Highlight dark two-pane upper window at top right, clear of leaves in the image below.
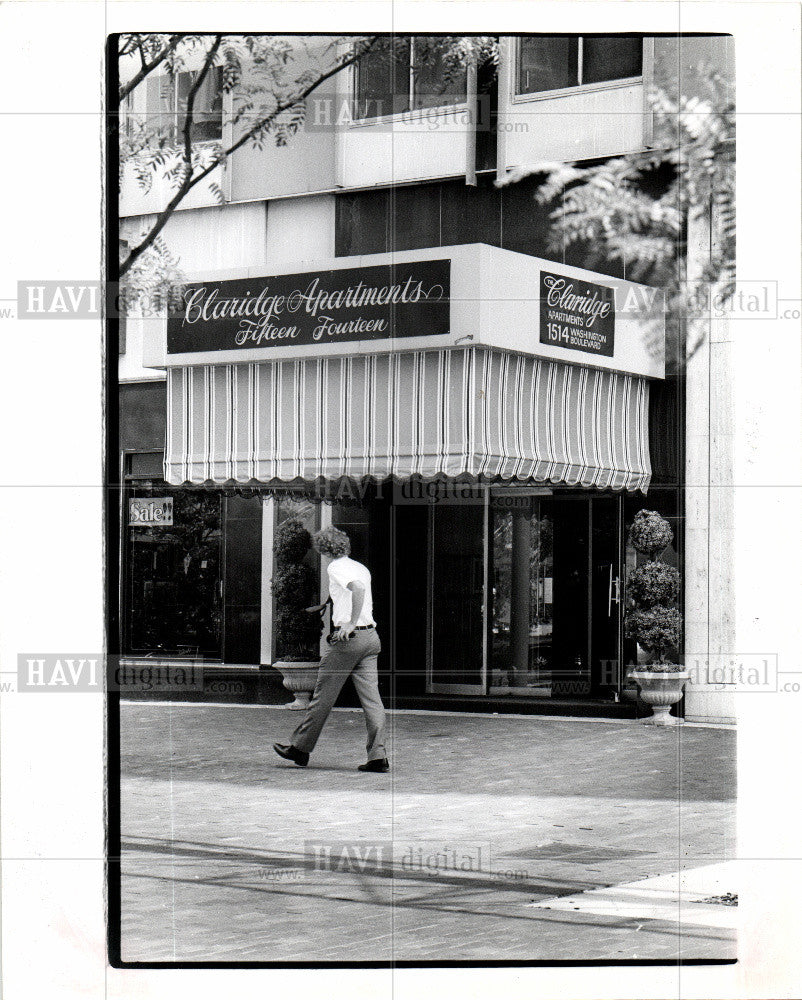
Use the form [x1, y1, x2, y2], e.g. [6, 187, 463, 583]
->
[517, 35, 643, 94]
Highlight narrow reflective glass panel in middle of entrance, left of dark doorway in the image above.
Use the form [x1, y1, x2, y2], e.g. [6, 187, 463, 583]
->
[490, 492, 554, 697]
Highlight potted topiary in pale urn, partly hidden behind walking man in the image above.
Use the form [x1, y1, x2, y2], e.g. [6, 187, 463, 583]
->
[273, 518, 323, 710]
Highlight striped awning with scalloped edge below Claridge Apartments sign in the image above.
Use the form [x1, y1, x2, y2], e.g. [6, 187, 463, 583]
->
[165, 347, 651, 492]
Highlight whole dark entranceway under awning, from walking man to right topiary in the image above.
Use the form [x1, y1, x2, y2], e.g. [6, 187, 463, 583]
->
[302, 486, 624, 701]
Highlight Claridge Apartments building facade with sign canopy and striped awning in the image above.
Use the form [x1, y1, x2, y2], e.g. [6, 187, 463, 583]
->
[119, 35, 734, 721]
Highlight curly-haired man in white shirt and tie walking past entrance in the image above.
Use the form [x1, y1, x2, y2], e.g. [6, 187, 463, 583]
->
[273, 527, 390, 773]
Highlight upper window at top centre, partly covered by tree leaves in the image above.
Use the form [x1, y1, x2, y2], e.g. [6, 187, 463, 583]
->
[354, 35, 465, 119]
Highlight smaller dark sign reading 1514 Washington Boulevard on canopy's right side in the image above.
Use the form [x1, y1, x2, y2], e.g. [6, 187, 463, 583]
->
[540, 271, 615, 358]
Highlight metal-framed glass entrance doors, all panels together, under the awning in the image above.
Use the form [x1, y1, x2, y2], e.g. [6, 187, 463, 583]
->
[418, 487, 623, 701]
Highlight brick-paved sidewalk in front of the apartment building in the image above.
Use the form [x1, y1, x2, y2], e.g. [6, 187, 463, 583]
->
[115, 703, 735, 962]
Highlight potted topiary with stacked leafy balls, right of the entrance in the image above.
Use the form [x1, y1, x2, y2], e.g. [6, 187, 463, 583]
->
[624, 510, 689, 726]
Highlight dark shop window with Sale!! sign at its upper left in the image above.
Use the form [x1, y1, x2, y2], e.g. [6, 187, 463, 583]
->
[125, 482, 222, 659]
